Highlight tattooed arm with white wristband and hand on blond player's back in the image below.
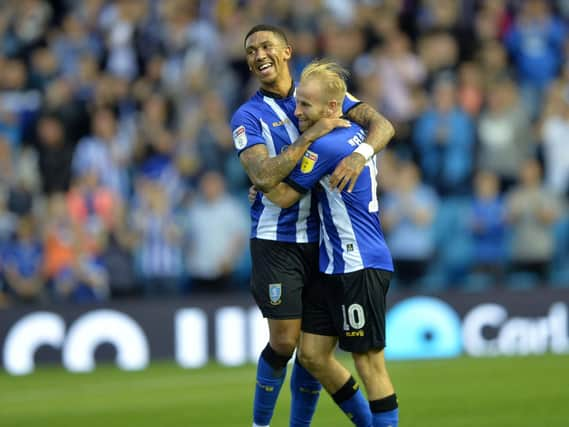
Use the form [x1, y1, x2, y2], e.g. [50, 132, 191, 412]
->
[330, 102, 395, 192]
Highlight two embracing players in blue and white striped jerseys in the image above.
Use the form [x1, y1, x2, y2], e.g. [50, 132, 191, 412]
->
[231, 25, 398, 427]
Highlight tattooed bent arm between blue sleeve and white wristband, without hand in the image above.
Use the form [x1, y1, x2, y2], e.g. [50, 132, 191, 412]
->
[347, 103, 395, 153]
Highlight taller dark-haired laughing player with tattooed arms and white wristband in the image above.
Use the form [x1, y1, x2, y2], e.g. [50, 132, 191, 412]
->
[231, 25, 394, 427]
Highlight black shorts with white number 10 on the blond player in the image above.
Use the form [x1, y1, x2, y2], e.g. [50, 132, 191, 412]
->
[302, 269, 392, 353]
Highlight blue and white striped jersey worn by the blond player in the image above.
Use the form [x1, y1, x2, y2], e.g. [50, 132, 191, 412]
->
[286, 123, 393, 274]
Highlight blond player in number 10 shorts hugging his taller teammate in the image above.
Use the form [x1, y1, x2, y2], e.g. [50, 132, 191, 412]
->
[265, 61, 398, 427]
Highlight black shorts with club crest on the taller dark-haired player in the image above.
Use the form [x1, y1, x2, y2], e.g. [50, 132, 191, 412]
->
[250, 239, 319, 319]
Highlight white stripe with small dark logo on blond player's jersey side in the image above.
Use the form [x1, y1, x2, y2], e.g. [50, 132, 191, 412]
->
[320, 175, 364, 273]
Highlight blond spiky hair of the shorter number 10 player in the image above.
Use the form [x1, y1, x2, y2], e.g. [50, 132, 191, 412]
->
[300, 59, 350, 103]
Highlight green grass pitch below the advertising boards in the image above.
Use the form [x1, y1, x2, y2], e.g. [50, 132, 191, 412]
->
[0, 355, 569, 427]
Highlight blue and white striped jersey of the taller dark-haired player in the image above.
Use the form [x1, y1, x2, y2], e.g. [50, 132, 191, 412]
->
[231, 85, 360, 243]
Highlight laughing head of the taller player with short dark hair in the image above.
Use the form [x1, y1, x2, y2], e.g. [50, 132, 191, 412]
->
[245, 31, 292, 91]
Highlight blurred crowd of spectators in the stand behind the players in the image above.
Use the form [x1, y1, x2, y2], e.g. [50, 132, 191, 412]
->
[0, 0, 569, 306]
